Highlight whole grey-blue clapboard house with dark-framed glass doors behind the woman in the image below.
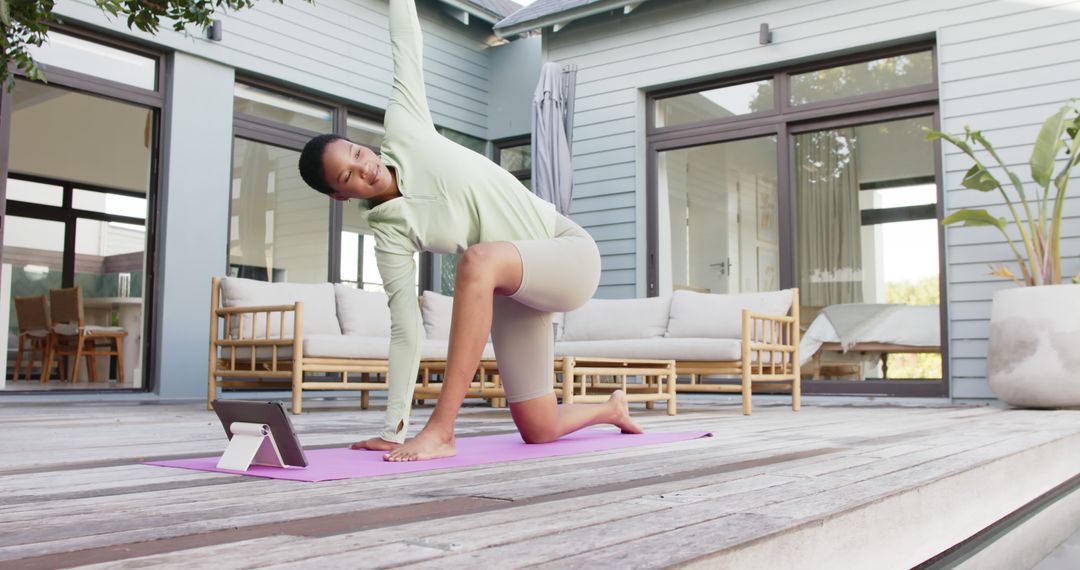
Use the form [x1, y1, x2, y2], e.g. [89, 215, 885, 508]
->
[0, 0, 1080, 398]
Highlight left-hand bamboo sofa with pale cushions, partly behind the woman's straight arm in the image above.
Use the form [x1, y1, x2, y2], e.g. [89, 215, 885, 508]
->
[206, 277, 495, 413]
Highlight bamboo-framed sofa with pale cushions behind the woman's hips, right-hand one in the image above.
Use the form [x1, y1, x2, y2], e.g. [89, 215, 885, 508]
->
[555, 288, 801, 415]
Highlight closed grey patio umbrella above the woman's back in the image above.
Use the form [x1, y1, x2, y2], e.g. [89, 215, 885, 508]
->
[532, 62, 577, 215]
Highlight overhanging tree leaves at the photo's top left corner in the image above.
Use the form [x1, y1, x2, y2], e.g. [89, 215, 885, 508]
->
[0, 0, 300, 90]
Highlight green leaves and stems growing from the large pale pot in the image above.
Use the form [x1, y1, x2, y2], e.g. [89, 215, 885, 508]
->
[927, 99, 1080, 285]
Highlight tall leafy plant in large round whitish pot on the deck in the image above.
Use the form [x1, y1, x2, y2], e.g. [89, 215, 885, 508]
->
[927, 99, 1080, 408]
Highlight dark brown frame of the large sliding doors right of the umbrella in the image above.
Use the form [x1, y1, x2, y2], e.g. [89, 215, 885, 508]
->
[645, 40, 950, 397]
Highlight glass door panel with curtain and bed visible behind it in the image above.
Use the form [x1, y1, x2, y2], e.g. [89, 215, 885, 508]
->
[794, 117, 942, 381]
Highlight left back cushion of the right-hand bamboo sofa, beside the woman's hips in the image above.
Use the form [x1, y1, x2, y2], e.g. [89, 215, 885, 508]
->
[559, 297, 671, 340]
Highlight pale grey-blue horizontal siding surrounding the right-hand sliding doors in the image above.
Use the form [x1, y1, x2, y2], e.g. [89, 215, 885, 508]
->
[544, 0, 1080, 398]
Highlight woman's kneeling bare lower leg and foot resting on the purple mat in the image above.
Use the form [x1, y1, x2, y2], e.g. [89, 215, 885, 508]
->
[510, 390, 643, 444]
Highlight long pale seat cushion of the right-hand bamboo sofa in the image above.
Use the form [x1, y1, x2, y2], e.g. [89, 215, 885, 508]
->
[555, 338, 742, 362]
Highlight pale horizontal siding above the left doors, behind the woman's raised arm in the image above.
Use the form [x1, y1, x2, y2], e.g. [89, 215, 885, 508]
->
[56, 0, 490, 139]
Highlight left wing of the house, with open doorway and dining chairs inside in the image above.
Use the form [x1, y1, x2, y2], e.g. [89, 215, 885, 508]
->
[0, 0, 540, 397]
